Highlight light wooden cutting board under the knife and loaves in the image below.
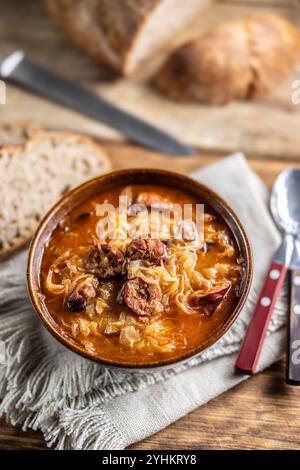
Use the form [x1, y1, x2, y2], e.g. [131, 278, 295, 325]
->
[0, 0, 300, 159]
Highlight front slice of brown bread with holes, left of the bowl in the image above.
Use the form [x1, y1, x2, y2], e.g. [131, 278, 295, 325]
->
[0, 128, 111, 258]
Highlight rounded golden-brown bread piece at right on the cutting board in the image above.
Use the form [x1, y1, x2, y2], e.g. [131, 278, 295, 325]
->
[154, 13, 300, 104]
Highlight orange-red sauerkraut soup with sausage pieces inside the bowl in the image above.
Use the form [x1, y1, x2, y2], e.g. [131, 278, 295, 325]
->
[41, 185, 243, 365]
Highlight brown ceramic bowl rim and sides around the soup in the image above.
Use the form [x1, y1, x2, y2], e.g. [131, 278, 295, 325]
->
[27, 169, 252, 371]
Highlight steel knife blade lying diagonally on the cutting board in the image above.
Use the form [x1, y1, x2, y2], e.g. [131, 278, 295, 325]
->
[0, 51, 195, 155]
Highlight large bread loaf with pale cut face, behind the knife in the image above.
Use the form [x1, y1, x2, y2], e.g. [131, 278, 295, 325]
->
[44, 0, 212, 76]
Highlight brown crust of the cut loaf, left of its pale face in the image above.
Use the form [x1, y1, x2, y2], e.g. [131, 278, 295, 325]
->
[44, 0, 161, 74]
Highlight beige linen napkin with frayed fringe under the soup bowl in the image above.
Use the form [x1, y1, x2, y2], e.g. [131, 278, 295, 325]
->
[0, 154, 286, 450]
